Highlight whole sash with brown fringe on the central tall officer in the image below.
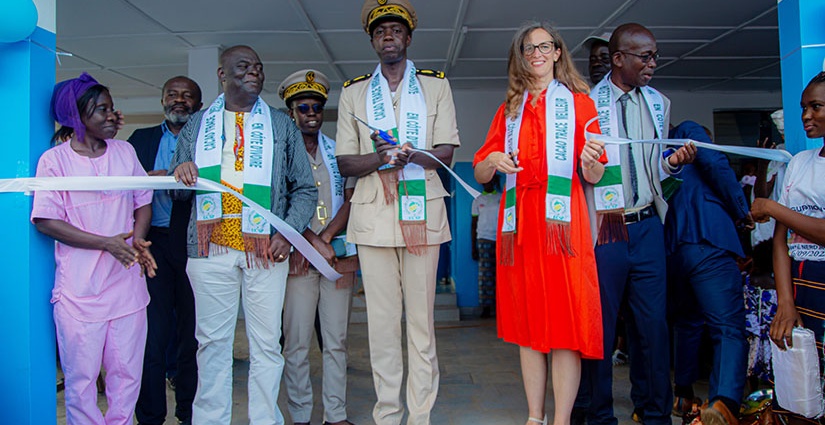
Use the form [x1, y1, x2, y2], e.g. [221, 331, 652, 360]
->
[366, 60, 427, 255]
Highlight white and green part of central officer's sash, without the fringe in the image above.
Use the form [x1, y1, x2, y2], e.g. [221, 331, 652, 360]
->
[366, 60, 427, 221]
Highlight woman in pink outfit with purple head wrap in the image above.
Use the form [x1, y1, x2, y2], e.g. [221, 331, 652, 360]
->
[31, 73, 157, 425]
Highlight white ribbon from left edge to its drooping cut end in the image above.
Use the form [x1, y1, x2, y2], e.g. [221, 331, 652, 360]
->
[0, 176, 342, 282]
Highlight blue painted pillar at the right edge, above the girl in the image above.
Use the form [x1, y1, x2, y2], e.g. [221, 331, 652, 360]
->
[778, 0, 825, 154]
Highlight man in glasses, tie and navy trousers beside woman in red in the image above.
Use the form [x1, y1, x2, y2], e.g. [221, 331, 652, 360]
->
[581, 23, 696, 425]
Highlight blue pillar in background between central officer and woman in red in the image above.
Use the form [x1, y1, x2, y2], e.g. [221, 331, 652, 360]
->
[450, 162, 482, 313]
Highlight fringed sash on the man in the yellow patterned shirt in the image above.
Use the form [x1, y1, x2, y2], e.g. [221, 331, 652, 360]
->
[195, 94, 275, 267]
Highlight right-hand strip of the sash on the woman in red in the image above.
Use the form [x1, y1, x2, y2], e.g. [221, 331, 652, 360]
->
[548, 80, 576, 223]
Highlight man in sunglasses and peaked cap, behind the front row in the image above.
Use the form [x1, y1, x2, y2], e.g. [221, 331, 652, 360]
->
[278, 69, 358, 425]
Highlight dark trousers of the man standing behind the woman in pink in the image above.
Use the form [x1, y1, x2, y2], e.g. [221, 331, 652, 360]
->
[135, 227, 198, 425]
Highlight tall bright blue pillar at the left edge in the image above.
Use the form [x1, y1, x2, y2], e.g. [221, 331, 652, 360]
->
[0, 0, 57, 424]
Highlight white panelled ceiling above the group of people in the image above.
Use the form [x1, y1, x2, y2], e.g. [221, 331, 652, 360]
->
[57, 0, 780, 101]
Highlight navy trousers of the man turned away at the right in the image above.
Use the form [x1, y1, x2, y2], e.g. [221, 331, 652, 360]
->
[667, 244, 748, 402]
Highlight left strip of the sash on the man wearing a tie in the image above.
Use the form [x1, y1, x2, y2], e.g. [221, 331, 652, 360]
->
[585, 74, 625, 212]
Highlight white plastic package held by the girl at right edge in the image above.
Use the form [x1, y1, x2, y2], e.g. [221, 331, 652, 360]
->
[771, 328, 825, 418]
